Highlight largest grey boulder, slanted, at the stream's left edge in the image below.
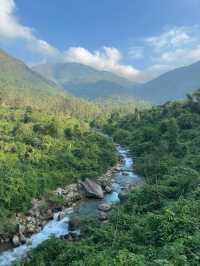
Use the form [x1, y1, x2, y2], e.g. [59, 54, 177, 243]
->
[81, 178, 104, 199]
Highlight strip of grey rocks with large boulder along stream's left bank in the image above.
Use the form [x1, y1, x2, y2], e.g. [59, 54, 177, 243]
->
[5, 158, 122, 246]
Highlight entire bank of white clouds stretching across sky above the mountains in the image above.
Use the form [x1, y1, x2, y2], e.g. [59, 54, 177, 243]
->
[0, 0, 200, 82]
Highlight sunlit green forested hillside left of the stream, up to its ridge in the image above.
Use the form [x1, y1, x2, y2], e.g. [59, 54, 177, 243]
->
[0, 48, 150, 250]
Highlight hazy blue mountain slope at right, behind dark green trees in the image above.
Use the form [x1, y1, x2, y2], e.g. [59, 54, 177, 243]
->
[134, 62, 200, 104]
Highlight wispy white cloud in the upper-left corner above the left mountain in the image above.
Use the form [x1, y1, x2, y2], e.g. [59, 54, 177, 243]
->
[0, 0, 60, 60]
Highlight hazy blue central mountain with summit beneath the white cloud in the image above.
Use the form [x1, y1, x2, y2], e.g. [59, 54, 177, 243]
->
[32, 63, 134, 100]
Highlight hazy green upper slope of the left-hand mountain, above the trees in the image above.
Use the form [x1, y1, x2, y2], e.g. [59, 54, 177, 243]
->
[0, 49, 61, 95]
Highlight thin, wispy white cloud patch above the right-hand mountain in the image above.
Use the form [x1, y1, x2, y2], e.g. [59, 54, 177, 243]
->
[139, 25, 200, 80]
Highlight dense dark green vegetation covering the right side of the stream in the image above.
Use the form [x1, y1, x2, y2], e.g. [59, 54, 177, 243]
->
[25, 91, 200, 266]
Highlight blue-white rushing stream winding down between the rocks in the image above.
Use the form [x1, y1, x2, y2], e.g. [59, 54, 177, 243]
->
[0, 146, 140, 266]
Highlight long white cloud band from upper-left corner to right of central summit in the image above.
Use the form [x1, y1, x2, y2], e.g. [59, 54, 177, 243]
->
[0, 0, 140, 80]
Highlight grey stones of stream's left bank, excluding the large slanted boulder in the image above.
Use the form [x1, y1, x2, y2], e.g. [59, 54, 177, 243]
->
[0, 152, 123, 251]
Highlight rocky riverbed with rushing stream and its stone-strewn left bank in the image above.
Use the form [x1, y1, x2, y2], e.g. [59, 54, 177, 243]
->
[0, 147, 141, 266]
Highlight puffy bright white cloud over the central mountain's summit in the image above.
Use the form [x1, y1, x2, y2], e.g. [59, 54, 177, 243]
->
[64, 47, 141, 81]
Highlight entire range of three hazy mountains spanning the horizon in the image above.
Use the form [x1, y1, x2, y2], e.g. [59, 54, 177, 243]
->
[0, 49, 200, 104]
